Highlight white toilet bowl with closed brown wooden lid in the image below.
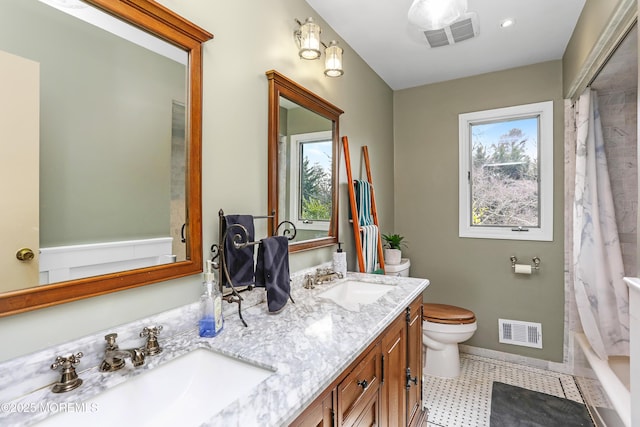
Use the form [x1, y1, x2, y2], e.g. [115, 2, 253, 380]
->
[422, 303, 478, 378]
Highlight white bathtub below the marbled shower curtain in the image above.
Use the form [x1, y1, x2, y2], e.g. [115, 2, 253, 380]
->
[575, 333, 631, 427]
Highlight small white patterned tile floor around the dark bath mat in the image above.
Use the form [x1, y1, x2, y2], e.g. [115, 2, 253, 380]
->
[423, 354, 583, 427]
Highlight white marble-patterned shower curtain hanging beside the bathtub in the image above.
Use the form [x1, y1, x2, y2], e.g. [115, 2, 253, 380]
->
[573, 89, 629, 360]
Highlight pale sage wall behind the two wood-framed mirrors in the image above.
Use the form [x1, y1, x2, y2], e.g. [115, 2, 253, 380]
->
[0, 0, 394, 361]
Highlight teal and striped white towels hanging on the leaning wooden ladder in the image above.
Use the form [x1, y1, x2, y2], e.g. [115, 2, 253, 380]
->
[353, 180, 378, 273]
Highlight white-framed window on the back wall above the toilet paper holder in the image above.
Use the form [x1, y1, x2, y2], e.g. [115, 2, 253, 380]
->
[459, 101, 553, 241]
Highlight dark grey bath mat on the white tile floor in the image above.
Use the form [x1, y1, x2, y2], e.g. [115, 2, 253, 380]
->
[490, 382, 593, 427]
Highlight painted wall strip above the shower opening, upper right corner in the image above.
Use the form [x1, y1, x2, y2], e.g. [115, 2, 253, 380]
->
[562, 0, 622, 96]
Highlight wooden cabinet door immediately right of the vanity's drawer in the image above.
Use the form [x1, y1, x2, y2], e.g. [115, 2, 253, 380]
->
[380, 315, 407, 427]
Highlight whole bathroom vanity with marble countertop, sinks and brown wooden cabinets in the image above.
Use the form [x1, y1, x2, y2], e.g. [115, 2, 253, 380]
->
[0, 270, 429, 426]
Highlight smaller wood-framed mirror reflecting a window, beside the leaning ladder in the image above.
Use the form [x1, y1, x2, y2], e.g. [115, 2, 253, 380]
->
[266, 70, 343, 252]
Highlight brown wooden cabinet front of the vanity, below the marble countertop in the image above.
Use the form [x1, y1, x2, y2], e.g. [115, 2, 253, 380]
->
[291, 296, 426, 427]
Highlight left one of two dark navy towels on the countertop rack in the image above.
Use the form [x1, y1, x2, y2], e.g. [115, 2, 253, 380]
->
[221, 215, 255, 286]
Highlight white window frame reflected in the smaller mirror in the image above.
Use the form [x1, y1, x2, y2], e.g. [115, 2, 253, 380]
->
[289, 130, 335, 232]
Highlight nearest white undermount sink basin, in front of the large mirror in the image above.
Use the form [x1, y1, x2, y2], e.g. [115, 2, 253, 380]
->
[38, 348, 273, 427]
